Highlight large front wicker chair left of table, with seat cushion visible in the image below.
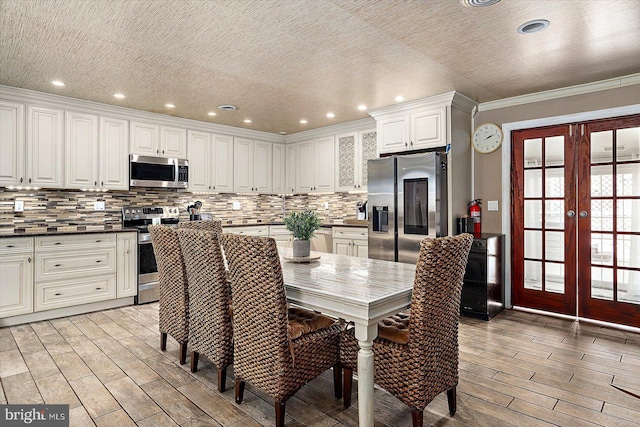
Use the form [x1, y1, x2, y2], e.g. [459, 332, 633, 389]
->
[221, 234, 342, 426]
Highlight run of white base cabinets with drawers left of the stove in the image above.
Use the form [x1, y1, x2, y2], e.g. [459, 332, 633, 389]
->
[0, 232, 137, 326]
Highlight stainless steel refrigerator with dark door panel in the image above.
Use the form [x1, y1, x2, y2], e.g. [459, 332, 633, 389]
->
[367, 152, 448, 263]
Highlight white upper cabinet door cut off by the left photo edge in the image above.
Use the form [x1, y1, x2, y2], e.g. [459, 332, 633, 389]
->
[0, 99, 26, 187]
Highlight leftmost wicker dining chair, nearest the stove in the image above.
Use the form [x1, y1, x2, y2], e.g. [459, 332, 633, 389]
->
[149, 225, 189, 365]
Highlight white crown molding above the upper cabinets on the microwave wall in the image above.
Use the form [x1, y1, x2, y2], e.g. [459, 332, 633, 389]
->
[0, 85, 284, 143]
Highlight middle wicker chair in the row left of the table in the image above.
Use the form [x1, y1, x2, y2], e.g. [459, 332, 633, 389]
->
[177, 229, 233, 392]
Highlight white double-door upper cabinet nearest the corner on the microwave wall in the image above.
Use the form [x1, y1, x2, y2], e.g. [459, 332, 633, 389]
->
[233, 137, 273, 194]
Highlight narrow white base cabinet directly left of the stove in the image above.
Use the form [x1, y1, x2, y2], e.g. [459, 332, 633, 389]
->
[116, 233, 138, 298]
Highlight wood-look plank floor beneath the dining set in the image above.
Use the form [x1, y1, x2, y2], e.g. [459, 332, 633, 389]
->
[0, 303, 640, 427]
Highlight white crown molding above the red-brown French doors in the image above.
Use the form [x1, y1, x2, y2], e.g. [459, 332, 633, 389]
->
[478, 73, 640, 111]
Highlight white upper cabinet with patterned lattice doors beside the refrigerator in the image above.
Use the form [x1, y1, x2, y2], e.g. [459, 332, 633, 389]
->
[335, 129, 378, 191]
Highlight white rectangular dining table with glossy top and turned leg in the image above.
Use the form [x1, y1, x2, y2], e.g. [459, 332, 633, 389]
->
[278, 246, 416, 427]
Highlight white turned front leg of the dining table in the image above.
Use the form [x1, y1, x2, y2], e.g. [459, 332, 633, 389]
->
[355, 323, 378, 427]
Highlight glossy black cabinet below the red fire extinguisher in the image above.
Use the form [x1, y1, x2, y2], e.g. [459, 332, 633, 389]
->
[460, 234, 504, 320]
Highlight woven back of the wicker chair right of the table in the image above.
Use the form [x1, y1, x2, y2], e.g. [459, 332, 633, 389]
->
[409, 233, 473, 383]
